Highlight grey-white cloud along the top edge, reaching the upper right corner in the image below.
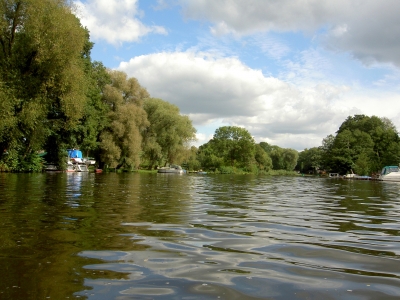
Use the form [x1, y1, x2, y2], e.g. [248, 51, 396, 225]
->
[180, 0, 400, 67]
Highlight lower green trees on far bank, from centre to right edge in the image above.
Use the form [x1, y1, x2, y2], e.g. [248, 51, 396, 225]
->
[188, 115, 400, 175]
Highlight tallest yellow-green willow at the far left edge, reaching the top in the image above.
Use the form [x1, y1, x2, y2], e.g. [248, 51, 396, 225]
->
[0, 0, 88, 169]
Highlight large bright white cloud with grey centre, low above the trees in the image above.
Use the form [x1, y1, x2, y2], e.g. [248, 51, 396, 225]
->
[118, 52, 368, 149]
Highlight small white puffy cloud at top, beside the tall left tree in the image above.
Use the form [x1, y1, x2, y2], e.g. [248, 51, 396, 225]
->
[75, 0, 167, 45]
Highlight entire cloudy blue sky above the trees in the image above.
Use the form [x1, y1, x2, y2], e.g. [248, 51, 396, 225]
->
[75, 0, 400, 150]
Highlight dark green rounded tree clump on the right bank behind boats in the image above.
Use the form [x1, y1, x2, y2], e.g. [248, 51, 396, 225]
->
[297, 115, 400, 175]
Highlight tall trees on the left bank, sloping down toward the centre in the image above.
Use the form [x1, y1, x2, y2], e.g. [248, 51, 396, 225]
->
[0, 0, 196, 172]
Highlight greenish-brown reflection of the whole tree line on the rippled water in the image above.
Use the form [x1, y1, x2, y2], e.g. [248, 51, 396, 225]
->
[0, 173, 400, 299]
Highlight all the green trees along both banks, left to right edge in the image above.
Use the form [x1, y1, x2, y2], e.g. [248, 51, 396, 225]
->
[0, 0, 400, 175]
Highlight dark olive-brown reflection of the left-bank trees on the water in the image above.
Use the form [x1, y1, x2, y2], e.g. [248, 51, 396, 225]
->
[0, 173, 173, 299]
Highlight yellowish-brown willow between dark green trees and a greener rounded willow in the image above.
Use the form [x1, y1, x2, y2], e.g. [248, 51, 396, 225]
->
[100, 70, 149, 168]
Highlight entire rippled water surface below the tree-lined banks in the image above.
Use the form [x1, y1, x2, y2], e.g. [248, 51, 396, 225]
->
[0, 173, 400, 300]
